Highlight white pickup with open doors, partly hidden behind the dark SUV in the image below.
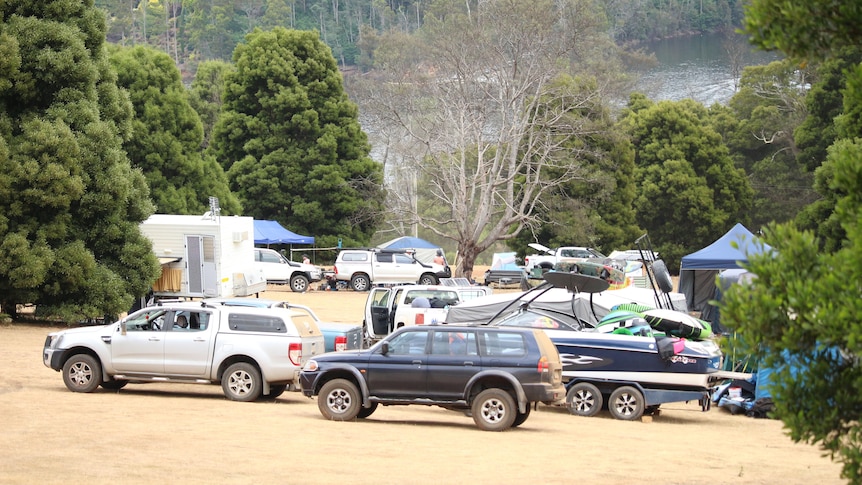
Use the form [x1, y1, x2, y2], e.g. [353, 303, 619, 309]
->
[362, 285, 493, 345]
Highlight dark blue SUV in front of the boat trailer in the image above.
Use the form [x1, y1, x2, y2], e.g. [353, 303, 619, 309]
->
[300, 325, 565, 431]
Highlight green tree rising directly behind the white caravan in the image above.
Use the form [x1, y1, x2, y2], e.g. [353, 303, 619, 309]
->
[110, 46, 240, 214]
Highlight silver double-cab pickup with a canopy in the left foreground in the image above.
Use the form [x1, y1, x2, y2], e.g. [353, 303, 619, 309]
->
[42, 302, 324, 401]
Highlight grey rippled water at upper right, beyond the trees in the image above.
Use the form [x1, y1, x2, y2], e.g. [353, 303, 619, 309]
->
[636, 34, 780, 106]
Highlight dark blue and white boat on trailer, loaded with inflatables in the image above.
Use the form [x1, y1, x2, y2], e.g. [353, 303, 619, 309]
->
[482, 271, 740, 420]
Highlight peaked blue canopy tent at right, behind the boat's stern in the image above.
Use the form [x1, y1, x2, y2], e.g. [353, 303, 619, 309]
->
[679, 223, 772, 328]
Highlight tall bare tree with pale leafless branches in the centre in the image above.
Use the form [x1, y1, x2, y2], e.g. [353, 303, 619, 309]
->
[363, 0, 624, 276]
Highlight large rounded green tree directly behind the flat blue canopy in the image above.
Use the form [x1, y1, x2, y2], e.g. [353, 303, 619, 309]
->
[211, 28, 383, 244]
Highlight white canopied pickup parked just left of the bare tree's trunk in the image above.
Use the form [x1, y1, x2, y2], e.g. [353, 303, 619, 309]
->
[334, 249, 452, 291]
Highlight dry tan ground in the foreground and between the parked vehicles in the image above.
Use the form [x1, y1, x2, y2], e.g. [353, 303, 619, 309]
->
[0, 287, 843, 485]
